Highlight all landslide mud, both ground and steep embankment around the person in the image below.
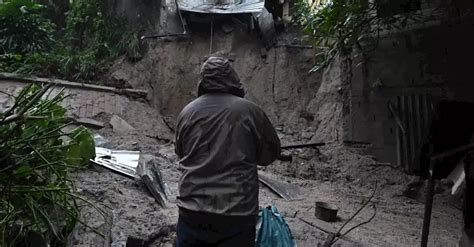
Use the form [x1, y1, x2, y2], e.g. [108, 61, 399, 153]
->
[70, 23, 462, 246]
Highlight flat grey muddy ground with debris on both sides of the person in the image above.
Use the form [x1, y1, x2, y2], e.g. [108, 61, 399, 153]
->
[71, 106, 461, 246]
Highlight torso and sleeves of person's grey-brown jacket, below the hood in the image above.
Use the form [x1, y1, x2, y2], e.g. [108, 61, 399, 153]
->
[176, 93, 280, 216]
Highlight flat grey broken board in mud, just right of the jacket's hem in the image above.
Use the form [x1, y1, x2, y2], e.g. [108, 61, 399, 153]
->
[258, 171, 303, 201]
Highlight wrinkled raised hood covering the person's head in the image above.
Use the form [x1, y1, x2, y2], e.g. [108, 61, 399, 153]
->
[198, 57, 245, 97]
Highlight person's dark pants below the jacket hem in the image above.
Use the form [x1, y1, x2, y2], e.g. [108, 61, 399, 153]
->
[176, 208, 257, 247]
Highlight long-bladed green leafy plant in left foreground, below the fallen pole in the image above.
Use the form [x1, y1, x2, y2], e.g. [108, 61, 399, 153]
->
[0, 84, 95, 246]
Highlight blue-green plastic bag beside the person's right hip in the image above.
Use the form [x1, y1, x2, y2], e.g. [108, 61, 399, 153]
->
[255, 206, 296, 247]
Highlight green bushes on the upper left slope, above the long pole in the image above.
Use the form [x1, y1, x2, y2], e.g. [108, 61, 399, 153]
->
[0, 0, 143, 81]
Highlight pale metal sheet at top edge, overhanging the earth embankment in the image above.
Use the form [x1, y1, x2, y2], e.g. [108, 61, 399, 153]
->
[178, 0, 265, 14]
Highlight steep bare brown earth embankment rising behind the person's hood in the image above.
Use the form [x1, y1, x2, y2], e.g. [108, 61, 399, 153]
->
[106, 28, 321, 131]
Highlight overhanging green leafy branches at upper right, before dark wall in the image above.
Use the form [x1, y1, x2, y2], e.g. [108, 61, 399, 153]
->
[293, 0, 419, 71]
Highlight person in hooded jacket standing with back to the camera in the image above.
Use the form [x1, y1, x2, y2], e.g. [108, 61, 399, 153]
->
[175, 57, 280, 247]
